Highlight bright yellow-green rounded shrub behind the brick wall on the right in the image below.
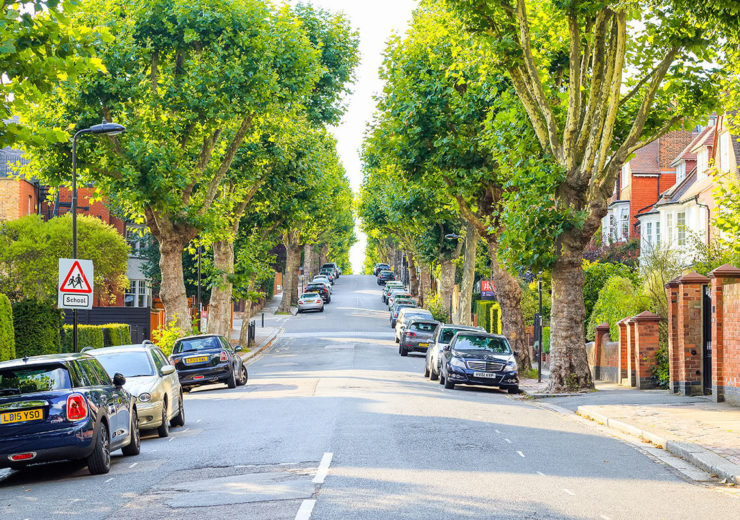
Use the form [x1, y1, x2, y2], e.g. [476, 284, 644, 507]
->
[587, 276, 650, 340]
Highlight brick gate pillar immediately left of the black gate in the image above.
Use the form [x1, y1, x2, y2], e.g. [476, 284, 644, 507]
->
[677, 271, 709, 395]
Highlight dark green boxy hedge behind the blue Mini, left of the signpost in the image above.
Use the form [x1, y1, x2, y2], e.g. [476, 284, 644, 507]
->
[13, 300, 63, 358]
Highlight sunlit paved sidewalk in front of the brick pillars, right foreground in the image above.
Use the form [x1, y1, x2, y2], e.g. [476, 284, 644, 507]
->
[520, 380, 740, 484]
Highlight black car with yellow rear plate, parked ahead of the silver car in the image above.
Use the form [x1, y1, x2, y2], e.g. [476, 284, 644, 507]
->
[170, 334, 248, 392]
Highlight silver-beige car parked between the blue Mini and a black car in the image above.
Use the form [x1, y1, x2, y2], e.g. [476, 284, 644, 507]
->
[88, 343, 185, 437]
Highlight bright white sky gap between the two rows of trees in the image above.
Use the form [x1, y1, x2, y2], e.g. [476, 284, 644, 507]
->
[292, 0, 418, 273]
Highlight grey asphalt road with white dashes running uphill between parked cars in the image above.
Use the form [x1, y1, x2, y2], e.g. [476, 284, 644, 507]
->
[0, 276, 740, 520]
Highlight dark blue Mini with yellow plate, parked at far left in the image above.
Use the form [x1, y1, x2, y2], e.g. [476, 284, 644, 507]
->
[0, 354, 140, 475]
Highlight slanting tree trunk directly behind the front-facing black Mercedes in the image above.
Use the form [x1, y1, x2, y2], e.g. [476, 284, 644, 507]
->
[488, 238, 532, 370]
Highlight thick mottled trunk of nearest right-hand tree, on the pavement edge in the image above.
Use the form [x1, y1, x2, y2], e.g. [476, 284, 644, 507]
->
[549, 247, 594, 392]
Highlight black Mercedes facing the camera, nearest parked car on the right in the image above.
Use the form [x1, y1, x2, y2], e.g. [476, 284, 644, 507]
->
[439, 332, 519, 394]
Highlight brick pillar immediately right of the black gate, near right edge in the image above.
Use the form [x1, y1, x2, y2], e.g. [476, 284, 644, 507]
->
[709, 264, 740, 402]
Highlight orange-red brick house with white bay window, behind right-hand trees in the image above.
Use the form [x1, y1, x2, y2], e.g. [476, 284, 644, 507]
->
[602, 130, 698, 243]
